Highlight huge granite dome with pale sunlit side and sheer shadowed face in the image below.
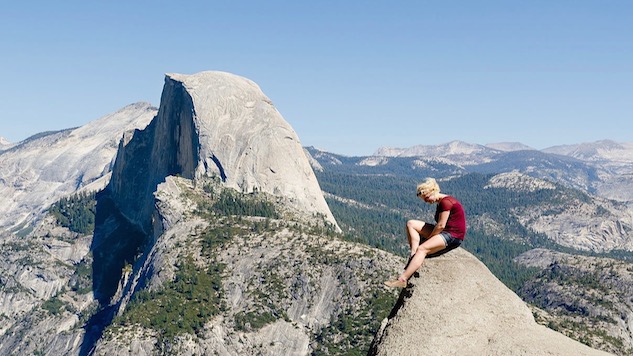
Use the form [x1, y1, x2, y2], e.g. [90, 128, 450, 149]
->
[110, 72, 336, 232]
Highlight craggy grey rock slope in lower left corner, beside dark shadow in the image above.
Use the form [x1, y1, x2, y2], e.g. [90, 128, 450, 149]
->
[0, 217, 95, 355]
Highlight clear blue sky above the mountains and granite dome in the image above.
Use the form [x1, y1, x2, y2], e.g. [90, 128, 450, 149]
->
[0, 0, 633, 155]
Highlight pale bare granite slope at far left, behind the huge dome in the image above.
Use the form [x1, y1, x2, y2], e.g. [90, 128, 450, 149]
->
[0, 103, 156, 230]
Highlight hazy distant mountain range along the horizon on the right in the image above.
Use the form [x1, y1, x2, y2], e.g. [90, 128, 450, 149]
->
[366, 140, 633, 202]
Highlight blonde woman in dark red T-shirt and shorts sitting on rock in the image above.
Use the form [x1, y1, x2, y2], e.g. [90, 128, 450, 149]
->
[385, 178, 466, 288]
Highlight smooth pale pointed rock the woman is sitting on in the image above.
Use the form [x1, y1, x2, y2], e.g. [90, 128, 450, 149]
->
[369, 249, 606, 356]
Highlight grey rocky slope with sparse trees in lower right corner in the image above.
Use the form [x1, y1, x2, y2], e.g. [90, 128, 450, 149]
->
[515, 248, 633, 355]
